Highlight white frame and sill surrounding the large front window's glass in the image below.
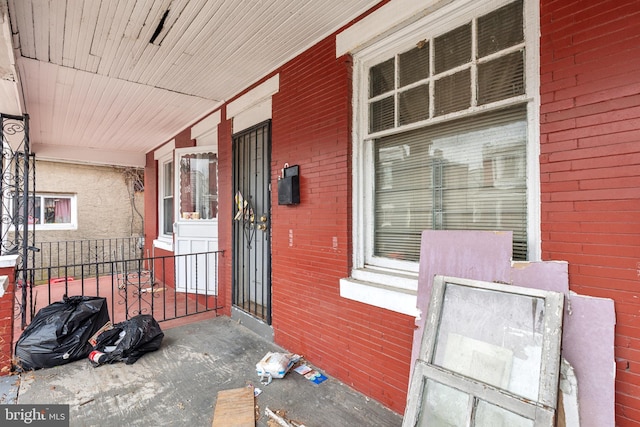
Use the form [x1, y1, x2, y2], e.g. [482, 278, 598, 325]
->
[340, 0, 541, 315]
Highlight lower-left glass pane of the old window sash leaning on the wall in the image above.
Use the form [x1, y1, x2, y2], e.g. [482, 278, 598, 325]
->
[417, 380, 472, 427]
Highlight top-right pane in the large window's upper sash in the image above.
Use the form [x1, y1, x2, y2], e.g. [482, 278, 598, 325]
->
[478, 1, 524, 58]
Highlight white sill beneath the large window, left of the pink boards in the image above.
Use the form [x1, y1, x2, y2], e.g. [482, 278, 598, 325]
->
[340, 268, 419, 317]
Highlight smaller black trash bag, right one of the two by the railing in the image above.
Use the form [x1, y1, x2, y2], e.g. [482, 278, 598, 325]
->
[89, 314, 164, 367]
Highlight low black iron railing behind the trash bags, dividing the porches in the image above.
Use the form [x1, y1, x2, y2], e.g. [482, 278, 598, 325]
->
[18, 249, 223, 323]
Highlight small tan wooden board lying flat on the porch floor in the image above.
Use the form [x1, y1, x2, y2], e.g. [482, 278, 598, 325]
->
[211, 387, 256, 427]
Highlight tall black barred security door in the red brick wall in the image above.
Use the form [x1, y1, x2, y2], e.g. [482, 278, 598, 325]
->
[233, 121, 271, 324]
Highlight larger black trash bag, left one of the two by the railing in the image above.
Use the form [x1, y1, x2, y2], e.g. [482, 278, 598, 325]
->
[15, 295, 110, 371]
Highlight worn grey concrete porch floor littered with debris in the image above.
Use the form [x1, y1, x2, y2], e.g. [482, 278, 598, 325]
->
[0, 317, 402, 427]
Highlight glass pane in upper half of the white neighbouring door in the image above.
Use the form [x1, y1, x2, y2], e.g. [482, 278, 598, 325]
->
[180, 153, 218, 219]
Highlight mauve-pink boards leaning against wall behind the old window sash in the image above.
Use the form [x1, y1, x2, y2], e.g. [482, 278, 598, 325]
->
[411, 230, 615, 427]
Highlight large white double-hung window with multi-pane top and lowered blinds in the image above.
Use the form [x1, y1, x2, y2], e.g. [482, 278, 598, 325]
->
[344, 0, 538, 314]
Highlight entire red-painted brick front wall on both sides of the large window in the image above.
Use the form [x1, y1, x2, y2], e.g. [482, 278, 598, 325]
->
[141, 0, 640, 427]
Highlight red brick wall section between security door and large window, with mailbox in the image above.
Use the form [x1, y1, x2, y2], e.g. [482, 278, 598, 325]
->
[272, 38, 414, 413]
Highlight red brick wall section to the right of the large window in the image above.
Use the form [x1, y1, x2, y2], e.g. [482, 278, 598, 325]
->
[540, 0, 640, 427]
